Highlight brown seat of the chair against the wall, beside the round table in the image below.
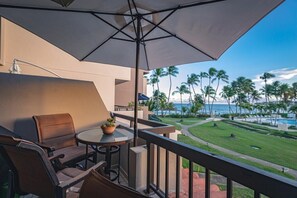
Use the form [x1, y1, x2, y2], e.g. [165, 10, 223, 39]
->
[54, 145, 95, 164]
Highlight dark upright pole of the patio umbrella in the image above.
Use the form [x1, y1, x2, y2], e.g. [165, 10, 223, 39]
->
[133, 15, 141, 146]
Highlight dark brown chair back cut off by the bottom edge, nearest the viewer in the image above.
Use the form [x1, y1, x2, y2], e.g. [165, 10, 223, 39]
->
[79, 170, 147, 198]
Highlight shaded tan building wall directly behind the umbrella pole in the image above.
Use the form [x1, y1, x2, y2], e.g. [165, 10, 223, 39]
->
[115, 69, 147, 106]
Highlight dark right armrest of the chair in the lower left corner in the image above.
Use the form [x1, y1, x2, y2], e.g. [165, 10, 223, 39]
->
[58, 161, 106, 190]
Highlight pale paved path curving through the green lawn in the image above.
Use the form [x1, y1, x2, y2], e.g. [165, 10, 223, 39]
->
[181, 119, 297, 178]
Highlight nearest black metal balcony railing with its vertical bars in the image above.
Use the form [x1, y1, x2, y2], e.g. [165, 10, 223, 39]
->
[139, 130, 297, 198]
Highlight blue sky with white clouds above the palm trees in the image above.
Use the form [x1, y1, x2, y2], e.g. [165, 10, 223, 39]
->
[147, 0, 297, 101]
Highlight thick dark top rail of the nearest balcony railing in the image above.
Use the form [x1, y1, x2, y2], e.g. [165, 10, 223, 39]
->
[139, 129, 297, 198]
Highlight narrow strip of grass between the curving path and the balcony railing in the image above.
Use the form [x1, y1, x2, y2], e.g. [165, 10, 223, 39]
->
[178, 135, 295, 179]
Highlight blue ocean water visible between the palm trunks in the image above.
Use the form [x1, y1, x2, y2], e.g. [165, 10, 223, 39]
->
[155, 103, 236, 115]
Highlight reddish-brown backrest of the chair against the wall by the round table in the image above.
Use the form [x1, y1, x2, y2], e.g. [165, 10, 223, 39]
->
[33, 113, 76, 149]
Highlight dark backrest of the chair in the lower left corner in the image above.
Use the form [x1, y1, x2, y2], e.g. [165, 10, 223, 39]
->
[0, 135, 59, 197]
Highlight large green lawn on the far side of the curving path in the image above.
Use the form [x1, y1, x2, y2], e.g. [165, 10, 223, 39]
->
[189, 122, 297, 170]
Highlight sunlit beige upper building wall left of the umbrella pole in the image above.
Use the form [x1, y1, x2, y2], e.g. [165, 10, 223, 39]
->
[0, 19, 131, 110]
